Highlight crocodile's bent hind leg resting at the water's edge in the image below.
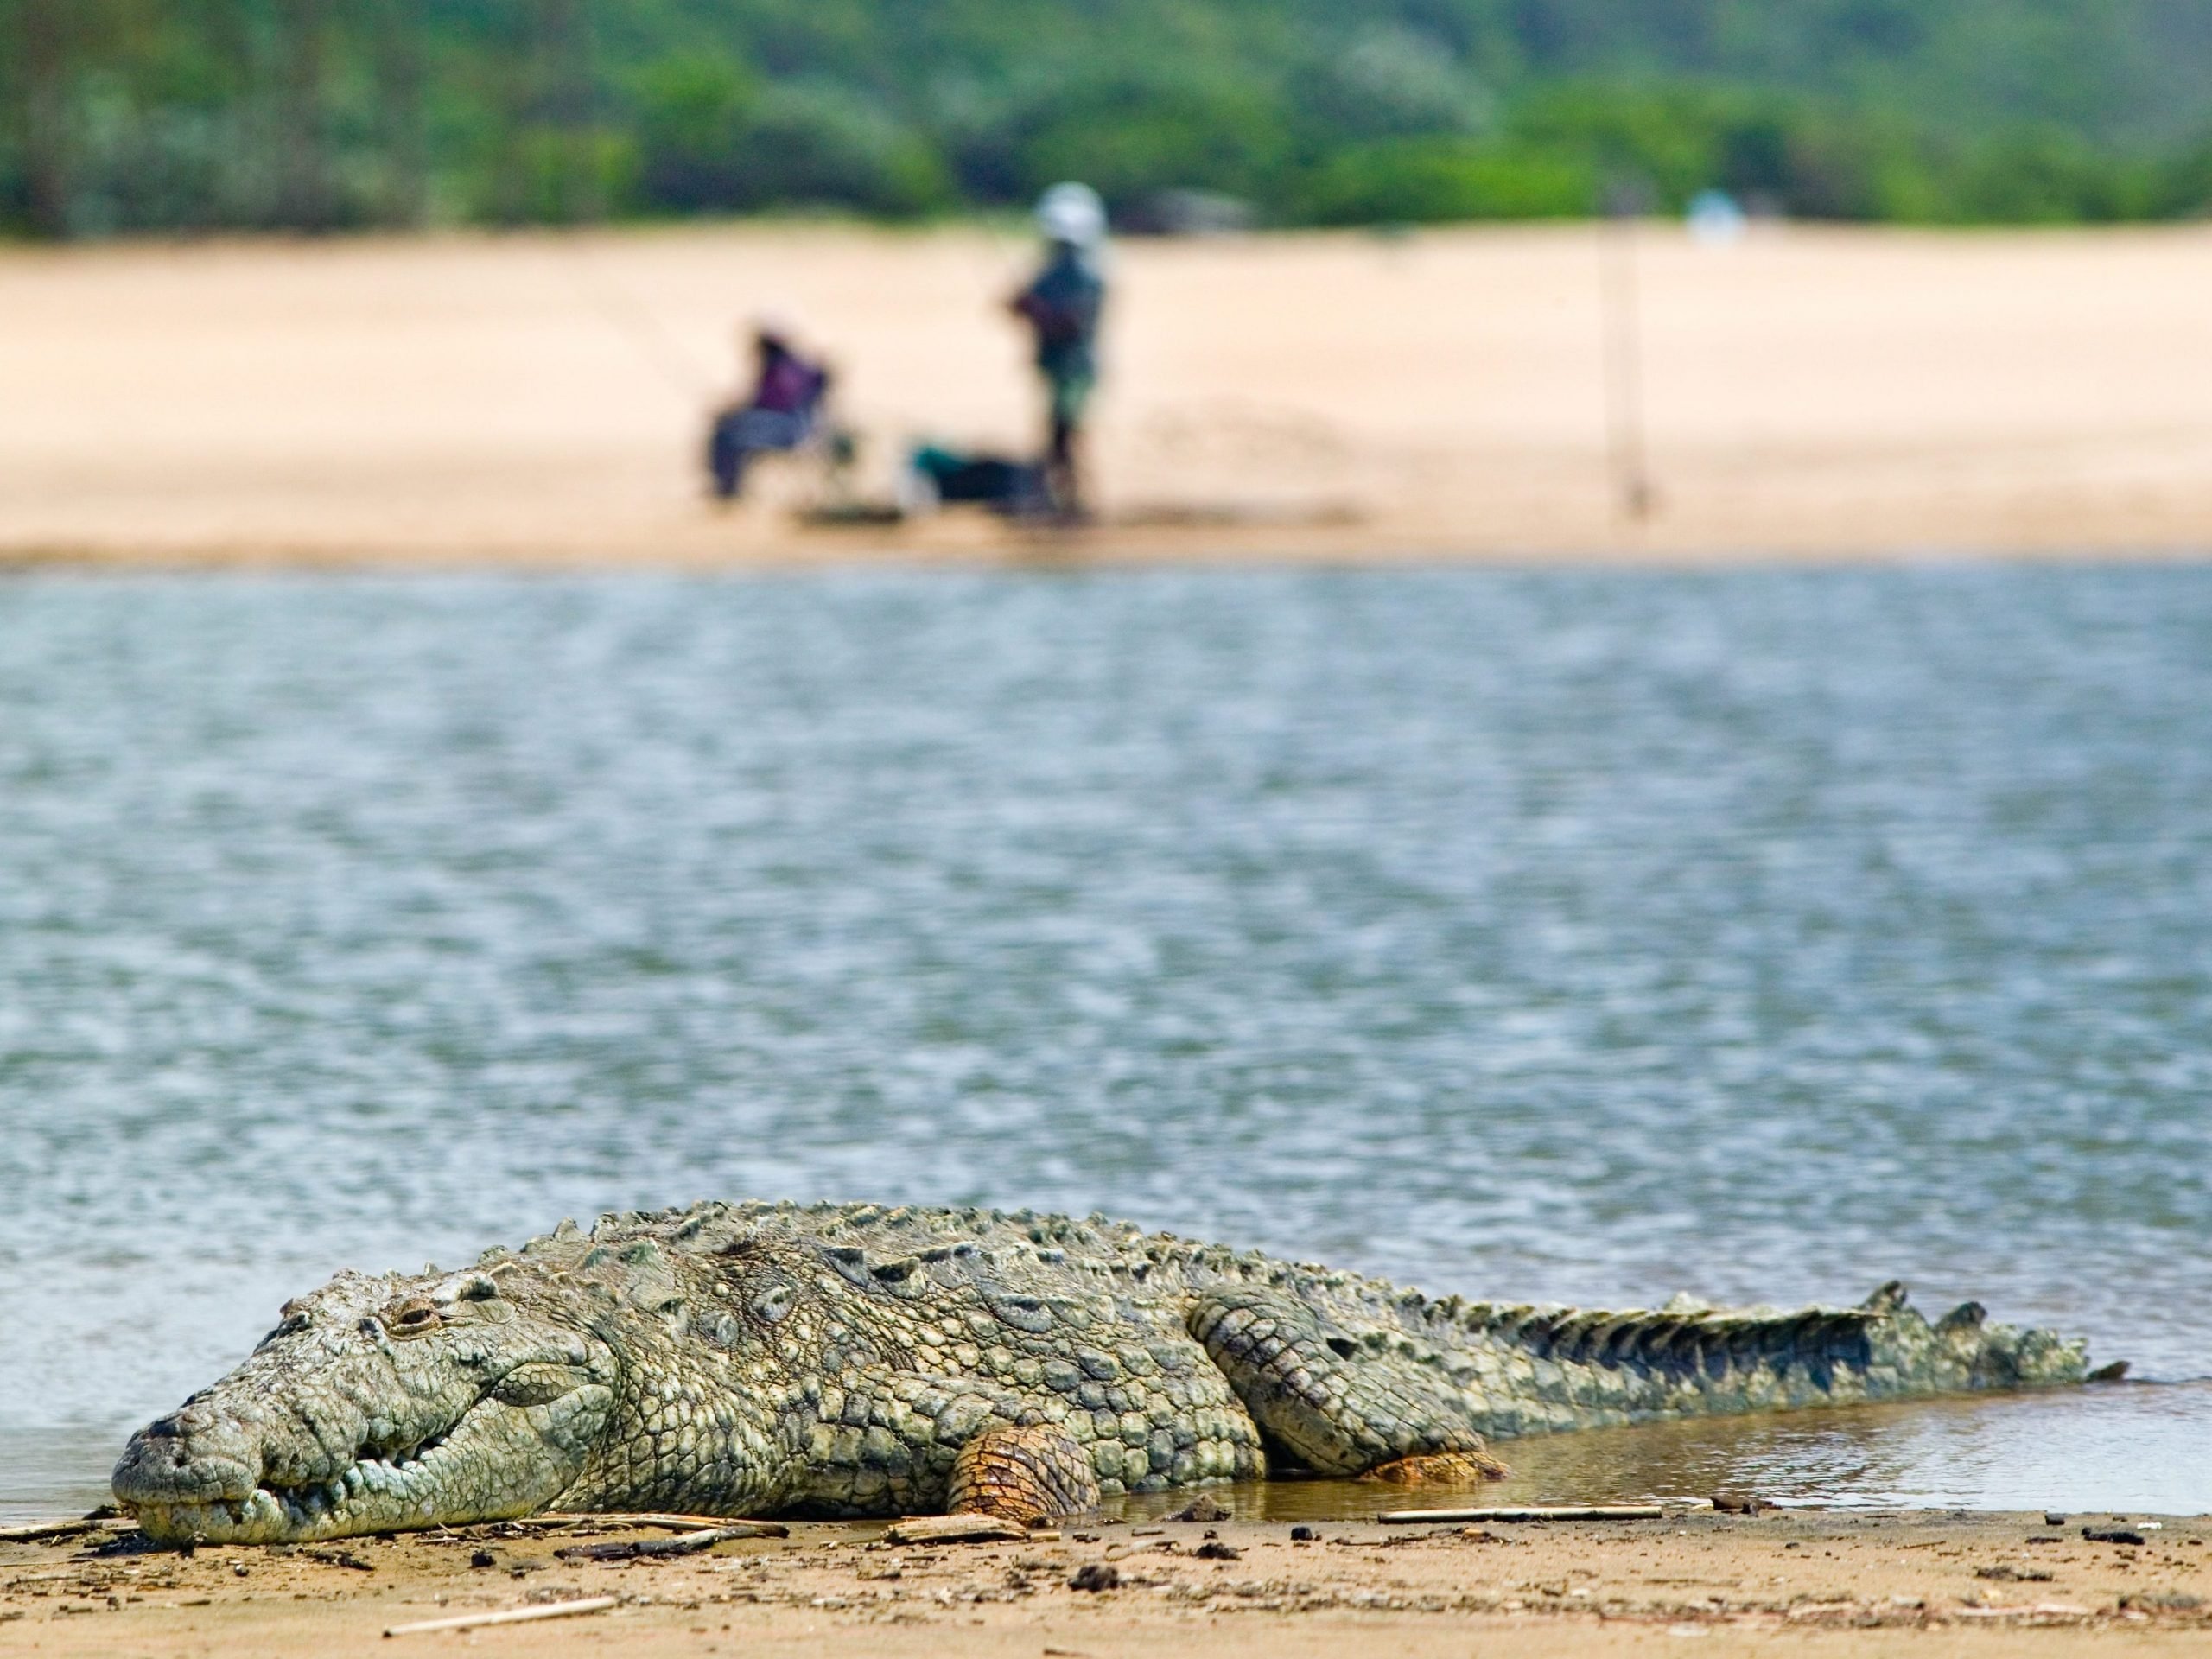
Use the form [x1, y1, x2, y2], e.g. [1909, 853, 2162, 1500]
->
[1190, 1287, 1506, 1484]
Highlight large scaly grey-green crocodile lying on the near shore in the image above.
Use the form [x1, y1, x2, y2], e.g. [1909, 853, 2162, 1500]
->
[113, 1204, 2117, 1544]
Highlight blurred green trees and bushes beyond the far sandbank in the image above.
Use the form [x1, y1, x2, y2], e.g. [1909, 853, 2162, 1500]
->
[0, 0, 2212, 237]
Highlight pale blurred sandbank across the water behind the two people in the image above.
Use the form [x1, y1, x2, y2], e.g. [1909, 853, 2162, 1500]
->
[0, 226, 2212, 566]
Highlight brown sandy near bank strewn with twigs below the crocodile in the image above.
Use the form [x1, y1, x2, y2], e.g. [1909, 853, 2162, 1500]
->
[0, 1500, 2212, 1659]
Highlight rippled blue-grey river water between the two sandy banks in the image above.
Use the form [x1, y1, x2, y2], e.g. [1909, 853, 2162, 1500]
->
[0, 566, 2212, 1516]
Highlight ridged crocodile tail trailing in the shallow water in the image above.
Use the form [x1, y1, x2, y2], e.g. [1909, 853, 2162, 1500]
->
[1460, 1283, 2088, 1433]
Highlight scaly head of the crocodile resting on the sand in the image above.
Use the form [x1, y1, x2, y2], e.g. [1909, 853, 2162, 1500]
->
[115, 1263, 615, 1544]
